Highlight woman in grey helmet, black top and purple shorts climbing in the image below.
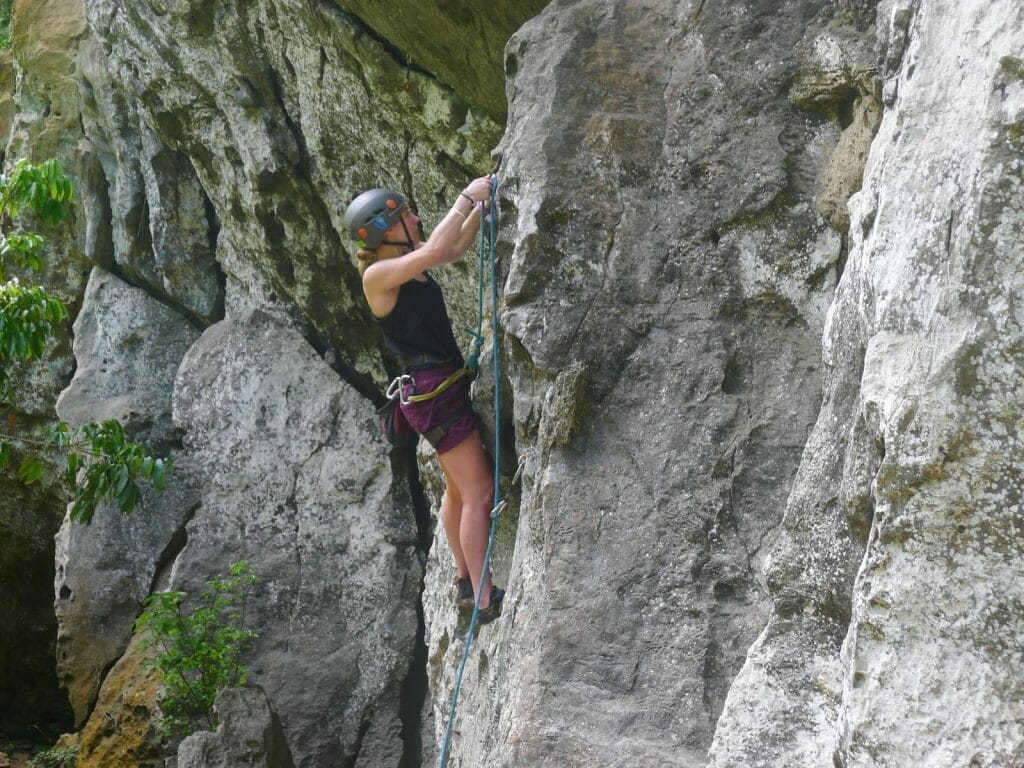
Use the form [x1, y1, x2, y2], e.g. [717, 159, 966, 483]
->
[344, 176, 505, 624]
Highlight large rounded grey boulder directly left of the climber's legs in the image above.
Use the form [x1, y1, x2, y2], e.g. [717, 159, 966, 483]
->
[171, 313, 422, 768]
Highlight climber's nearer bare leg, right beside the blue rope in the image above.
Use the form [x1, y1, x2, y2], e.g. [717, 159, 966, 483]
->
[437, 431, 495, 608]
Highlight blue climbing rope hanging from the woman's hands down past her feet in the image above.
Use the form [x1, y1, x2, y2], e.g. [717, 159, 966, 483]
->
[437, 175, 505, 768]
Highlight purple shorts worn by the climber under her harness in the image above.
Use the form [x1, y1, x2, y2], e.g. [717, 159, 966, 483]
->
[401, 365, 476, 454]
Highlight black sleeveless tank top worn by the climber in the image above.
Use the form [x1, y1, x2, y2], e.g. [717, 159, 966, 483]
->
[376, 274, 461, 358]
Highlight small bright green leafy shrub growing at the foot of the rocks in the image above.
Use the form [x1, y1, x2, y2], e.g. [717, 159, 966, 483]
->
[135, 561, 259, 737]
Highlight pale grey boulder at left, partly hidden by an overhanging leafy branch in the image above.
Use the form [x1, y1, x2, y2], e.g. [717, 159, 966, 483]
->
[54, 267, 199, 724]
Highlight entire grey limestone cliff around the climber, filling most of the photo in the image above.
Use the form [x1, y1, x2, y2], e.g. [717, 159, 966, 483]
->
[11, 0, 1024, 768]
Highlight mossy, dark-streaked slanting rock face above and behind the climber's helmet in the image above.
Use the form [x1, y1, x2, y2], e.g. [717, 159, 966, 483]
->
[85, 0, 501, 379]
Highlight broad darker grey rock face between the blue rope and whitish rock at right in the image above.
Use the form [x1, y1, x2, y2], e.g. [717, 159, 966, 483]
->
[419, 0, 873, 766]
